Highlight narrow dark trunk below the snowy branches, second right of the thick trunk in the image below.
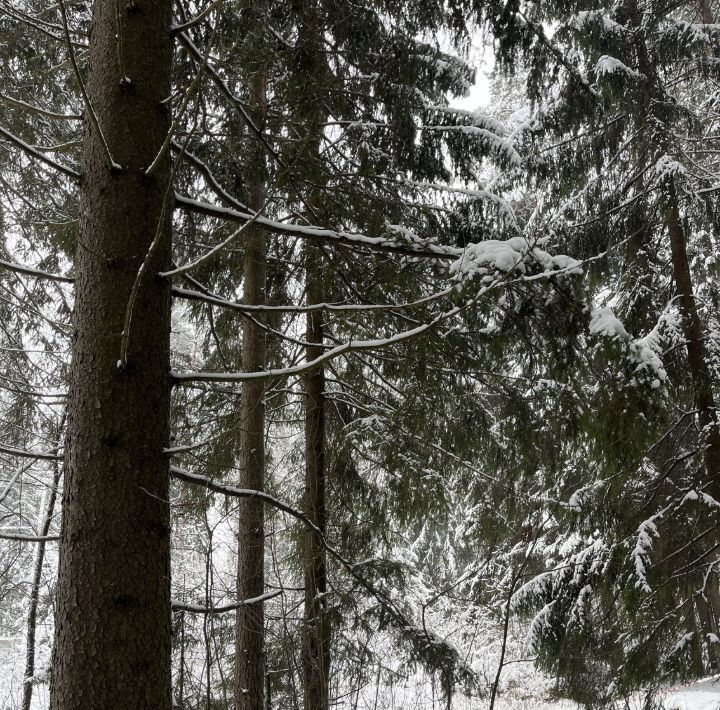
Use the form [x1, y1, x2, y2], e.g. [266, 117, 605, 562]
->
[302, 247, 330, 710]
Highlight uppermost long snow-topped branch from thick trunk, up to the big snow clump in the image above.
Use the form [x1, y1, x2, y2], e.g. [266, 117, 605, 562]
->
[172, 193, 462, 260]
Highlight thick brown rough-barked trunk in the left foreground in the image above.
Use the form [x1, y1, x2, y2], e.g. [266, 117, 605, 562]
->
[50, 0, 172, 710]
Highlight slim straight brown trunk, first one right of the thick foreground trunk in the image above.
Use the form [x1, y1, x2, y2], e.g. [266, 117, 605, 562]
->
[235, 0, 267, 710]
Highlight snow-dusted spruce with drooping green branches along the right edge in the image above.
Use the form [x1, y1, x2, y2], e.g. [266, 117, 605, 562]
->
[476, 0, 718, 706]
